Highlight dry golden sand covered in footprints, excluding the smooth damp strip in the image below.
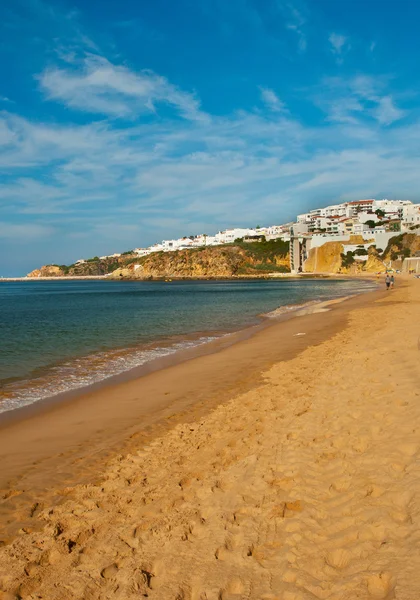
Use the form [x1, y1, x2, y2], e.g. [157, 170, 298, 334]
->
[0, 280, 420, 600]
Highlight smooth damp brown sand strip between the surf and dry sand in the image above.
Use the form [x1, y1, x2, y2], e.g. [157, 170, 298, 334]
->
[0, 290, 385, 536]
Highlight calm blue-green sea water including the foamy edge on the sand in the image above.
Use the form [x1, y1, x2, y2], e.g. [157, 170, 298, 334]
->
[0, 279, 372, 412]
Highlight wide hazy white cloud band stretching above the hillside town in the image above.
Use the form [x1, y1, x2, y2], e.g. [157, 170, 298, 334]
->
[0, 62, 420, 270]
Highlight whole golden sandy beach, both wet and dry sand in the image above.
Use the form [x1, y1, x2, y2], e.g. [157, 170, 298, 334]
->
[0, 278, 420, 600]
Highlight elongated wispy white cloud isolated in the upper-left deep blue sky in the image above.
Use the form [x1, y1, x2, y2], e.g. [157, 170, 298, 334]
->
[39, 54, 208, 122]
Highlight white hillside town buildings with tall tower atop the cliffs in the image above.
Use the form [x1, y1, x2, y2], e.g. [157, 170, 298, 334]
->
[76, 199, 420, 271]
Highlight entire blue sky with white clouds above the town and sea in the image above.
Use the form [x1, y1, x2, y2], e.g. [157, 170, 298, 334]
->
[0, 0, 420, 276]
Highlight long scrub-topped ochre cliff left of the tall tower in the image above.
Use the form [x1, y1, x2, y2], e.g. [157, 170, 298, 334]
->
[28, 240, 290, 279]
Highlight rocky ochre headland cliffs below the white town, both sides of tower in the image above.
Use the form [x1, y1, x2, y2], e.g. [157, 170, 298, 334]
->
[27, 233, 420, 279]
